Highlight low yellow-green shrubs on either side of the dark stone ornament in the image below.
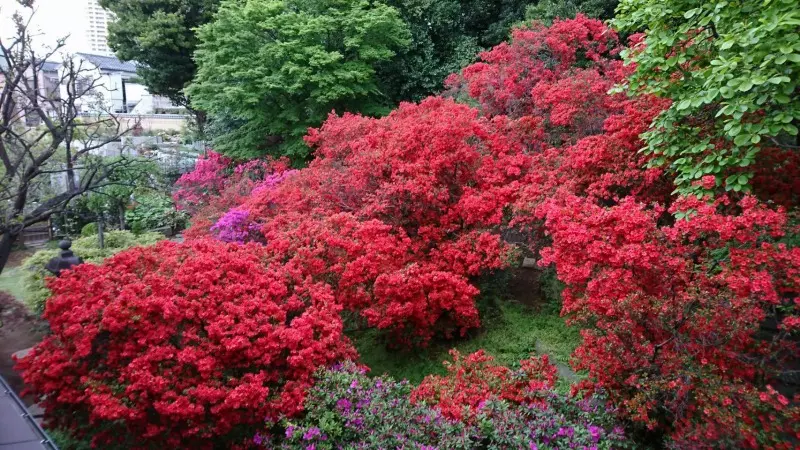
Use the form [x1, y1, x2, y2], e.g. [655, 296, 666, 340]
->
[22, 231, 164, 314]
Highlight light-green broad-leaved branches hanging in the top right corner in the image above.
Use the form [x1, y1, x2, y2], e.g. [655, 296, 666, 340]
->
[615, 0, 800, 195]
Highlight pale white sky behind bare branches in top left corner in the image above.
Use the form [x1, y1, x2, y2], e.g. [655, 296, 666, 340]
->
[0, 0, 85, 56]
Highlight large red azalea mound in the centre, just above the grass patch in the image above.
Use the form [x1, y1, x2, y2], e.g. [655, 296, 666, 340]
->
[242, 98, 530, 345]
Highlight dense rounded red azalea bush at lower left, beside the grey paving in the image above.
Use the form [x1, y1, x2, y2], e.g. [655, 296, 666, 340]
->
[18, 240, 355, 449]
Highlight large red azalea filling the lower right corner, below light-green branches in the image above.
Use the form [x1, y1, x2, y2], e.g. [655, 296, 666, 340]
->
[539, 196, 800, 448]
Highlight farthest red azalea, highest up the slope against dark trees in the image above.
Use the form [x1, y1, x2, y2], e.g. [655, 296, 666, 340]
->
[447, 14, 630, 150]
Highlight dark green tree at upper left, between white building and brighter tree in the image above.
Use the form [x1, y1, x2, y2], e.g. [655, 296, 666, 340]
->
[100, 0, 220, 105]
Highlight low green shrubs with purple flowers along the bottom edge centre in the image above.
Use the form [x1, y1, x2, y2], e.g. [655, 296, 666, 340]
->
[262, 363, 630, 450]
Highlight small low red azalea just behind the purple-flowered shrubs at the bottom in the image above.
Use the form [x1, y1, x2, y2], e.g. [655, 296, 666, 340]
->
[411, 350, 558, 421]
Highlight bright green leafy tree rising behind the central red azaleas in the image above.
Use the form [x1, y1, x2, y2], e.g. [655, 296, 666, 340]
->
[188, 0, 410, 159]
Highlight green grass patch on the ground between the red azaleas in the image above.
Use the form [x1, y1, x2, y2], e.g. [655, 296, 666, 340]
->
[350, 301, 580, 383]
